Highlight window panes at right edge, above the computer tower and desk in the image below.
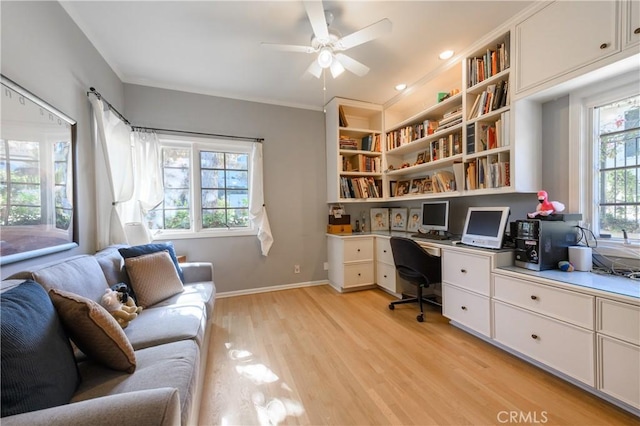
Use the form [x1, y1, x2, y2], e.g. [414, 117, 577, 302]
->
[592, 95, 640, 239]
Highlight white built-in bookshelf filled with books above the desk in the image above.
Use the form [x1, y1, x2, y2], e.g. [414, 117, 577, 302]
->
[327, 31, 541, 202]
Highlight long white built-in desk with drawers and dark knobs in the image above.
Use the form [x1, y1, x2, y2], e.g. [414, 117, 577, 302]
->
[327, 232, 640, 416]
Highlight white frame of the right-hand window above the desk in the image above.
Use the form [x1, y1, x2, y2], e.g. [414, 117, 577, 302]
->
[568, 72, 640, 255]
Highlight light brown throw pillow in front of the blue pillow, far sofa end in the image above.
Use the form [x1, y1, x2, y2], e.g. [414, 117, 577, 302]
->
[124, 251, 184, 308]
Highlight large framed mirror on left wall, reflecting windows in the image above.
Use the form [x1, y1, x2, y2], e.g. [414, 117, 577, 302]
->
[0, 75, 78, 265]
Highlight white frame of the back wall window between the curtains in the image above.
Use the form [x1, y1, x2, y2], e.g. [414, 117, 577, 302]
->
[150, 133, 263, 241]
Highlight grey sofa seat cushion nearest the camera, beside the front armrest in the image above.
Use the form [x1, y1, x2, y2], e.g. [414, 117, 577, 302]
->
[73, 340, 200, 425]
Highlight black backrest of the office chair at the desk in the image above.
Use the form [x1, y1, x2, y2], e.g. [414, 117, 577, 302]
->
[390, 237, 442, 284]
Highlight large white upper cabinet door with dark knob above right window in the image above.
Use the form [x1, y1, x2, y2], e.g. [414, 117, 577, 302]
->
[515, 1, 620, 92]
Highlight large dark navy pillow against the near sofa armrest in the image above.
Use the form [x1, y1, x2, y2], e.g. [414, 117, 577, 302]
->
[0, 281, 79, 417]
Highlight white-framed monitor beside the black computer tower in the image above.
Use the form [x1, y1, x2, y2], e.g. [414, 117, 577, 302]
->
[462, 207, 509, 249]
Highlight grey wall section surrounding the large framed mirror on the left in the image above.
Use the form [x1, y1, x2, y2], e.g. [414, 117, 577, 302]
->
[0, 1, 124, 278]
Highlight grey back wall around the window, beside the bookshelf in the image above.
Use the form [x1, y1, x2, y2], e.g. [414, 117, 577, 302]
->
[124, 84, 327, 292]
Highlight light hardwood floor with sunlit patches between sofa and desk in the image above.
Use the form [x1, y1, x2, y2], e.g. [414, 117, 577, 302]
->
[200, 285, 640, 425]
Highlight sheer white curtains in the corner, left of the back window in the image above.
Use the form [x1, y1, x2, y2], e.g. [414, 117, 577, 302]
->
[91, 98, 163, 249]
